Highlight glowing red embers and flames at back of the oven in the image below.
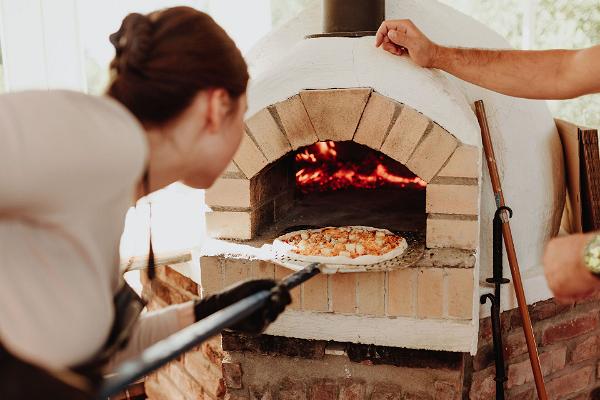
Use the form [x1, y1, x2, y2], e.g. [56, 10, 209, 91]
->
[295, 141, 427, 193]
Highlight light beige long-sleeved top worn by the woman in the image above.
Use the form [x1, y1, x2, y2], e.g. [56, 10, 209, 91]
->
[0, 91, 190, 368]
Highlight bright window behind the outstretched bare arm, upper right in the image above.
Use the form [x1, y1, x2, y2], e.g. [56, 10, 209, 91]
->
[442, 0, 600, 128]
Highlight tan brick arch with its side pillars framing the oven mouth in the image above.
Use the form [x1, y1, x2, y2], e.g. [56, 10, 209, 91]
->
[206, 88, 481, 250]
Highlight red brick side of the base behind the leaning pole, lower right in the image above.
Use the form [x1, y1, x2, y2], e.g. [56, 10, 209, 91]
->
[469, 299, 600, 400]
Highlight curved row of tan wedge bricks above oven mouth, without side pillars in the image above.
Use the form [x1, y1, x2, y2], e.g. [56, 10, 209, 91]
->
[234, 88, 468, 183]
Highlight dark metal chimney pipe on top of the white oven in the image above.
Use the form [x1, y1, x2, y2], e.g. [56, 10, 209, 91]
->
[323, 0, 385, 36]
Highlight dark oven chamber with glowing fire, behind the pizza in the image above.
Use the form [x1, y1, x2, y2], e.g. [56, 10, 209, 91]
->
[264, 141, 427, 238]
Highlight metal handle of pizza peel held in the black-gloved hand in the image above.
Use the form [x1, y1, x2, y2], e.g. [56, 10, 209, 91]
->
[97, 263, 320, 399]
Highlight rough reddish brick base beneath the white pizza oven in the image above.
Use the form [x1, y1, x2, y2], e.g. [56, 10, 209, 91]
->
[145, 267, 600, 400]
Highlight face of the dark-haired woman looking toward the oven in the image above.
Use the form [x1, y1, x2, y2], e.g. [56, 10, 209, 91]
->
[182, 94, 247, 189]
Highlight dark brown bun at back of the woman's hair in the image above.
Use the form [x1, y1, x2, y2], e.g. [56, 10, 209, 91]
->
[109, 13, 152, 73]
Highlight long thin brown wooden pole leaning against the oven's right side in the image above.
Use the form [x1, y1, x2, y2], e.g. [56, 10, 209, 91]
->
[475, 100, 548, 400]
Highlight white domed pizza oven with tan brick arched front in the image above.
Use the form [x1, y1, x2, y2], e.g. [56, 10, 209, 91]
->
[199, 0, 564, 354]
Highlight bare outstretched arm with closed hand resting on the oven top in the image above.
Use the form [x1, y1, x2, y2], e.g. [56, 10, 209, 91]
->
[376, 20, 600, 99]
